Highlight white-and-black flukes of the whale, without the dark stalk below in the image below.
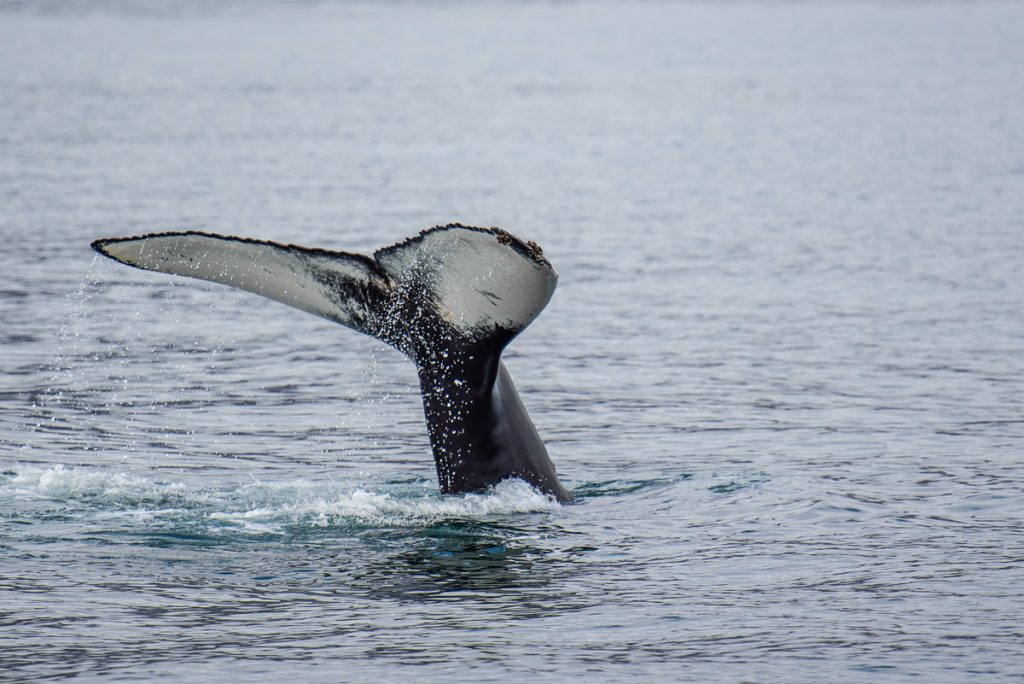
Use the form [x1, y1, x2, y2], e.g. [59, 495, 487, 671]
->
[92, 224, 558, 365]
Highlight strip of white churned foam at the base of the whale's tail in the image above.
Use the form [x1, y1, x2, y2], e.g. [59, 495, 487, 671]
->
[0, 465, 560, 535]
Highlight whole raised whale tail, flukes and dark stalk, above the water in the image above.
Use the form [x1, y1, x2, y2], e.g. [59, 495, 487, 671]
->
[92, 224, 570, 501]
